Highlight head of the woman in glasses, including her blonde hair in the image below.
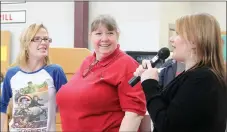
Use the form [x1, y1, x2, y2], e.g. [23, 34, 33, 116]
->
[15, 23, 52, 67]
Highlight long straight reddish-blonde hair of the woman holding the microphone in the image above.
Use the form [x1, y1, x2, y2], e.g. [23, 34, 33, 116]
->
[176, 13, 226, 81]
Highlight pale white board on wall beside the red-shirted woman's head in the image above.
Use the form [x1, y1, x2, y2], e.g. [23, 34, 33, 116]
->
[119, 21, 160, 51]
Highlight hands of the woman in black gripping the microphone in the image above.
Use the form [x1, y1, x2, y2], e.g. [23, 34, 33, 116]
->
[134, 60, 159, 82]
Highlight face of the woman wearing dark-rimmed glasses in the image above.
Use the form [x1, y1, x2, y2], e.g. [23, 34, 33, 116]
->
[28, 28, 51, 59]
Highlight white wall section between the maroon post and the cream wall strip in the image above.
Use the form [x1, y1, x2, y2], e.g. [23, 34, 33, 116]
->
[89, 2, 160, 50]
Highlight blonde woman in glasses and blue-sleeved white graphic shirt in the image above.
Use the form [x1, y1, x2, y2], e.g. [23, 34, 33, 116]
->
[0, 24, 67, 131]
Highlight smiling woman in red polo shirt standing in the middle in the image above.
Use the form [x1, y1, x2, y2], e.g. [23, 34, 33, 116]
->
[57, 15, 146, 132]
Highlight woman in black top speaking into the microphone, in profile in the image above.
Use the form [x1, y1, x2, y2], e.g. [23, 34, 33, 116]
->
[134, 13, 227, 132]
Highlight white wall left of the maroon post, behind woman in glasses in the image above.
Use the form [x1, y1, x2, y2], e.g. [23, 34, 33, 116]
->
[1, 2, 74, 63]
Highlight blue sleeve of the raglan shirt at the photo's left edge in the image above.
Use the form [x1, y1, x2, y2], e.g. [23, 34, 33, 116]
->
[0, 72, 12, 113]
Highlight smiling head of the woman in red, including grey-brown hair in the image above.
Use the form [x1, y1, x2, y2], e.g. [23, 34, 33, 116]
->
[90, 15, 119, 60]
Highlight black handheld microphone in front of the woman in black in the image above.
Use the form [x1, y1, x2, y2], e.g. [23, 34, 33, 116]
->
[128, 47, 170, 87]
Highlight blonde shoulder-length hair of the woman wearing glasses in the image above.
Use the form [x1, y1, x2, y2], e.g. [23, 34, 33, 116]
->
[15, 23, 50, 67]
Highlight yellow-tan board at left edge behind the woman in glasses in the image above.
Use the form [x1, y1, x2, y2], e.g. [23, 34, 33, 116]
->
[1, 31, 11, 75]
